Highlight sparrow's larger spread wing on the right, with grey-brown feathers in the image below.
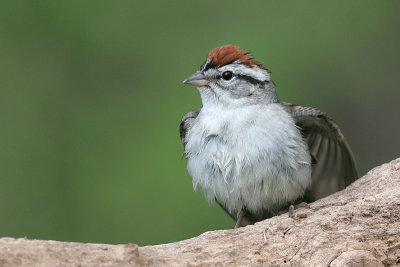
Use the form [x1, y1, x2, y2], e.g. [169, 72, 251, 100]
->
[283, 103, 358, 200]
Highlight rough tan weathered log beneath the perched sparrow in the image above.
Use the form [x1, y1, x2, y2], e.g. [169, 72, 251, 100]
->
[0, 158, 400, 266]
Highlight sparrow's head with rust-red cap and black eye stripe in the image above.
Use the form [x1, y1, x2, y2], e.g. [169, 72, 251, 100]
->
[183, 45, 278, 106]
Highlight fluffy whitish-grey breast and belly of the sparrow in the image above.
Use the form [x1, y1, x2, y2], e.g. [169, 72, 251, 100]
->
[185, 104, 311, 217]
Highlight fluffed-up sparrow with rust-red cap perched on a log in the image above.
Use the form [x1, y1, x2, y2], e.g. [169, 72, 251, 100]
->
[179, 45, 358, 228]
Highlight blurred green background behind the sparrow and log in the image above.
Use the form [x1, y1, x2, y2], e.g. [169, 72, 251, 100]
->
[0, 0, 400, 245]
